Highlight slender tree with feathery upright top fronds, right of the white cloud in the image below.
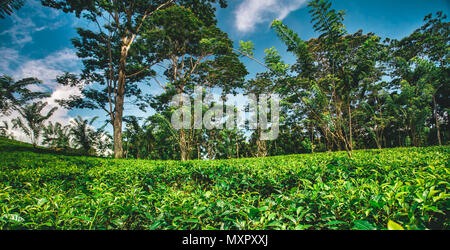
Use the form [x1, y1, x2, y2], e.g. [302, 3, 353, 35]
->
[272, 0, 381, 156]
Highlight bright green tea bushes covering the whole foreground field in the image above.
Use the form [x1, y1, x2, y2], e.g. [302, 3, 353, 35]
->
[0, 139, 450, 230]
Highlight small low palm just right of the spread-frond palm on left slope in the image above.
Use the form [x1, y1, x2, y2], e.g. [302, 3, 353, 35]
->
[42, 122, 70, 149]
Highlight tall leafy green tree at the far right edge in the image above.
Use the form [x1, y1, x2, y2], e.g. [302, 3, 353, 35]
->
[388, 12, 450, 145]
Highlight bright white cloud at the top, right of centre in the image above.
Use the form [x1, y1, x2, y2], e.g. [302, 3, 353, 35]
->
[234, 0, 306, 32]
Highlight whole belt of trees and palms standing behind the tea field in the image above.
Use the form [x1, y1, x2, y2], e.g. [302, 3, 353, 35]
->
[0, 0, 450, 160]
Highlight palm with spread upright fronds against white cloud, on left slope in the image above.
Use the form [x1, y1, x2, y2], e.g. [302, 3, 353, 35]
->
[11, 102, 58, 146]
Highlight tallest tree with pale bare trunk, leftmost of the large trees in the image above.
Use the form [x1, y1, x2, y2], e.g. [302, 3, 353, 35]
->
[46, 0, 226, 158]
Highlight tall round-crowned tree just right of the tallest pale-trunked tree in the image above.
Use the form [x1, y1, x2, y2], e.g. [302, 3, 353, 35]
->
[144, 6, 247, 160]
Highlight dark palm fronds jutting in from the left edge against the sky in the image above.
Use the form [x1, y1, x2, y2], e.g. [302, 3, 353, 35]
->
[0, 75, 50, 114]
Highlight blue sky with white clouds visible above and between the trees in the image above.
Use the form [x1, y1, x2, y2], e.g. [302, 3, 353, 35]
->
[0, 0, 450, 141]
